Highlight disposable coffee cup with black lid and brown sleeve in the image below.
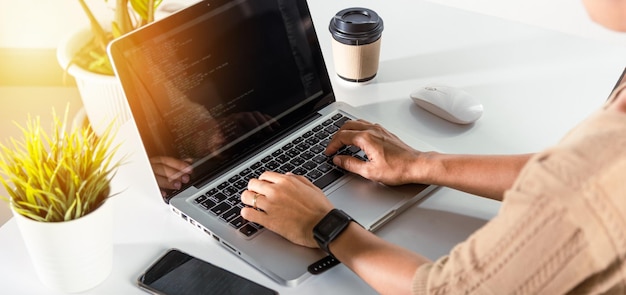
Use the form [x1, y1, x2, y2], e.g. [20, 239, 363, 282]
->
[329, 7, 383, 83]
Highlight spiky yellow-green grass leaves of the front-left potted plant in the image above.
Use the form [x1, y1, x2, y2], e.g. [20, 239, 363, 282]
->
[0, 108, 125, 222]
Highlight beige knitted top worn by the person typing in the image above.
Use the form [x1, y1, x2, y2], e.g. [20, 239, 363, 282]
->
[413, 87, 626, 295]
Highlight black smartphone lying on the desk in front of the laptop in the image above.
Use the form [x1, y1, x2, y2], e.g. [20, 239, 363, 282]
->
[137, 249, 278, 295]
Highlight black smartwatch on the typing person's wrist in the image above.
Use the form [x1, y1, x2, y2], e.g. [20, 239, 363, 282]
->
[313, 209, 354, 256]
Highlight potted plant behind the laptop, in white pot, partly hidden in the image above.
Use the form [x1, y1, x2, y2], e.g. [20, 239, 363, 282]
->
[57, 0, 162, 135]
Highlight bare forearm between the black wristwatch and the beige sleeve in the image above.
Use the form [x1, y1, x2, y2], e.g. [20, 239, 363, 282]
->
[330, 222, 429, 294]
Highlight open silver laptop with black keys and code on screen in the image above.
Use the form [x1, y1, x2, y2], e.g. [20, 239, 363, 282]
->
[109, 0, 435, 286]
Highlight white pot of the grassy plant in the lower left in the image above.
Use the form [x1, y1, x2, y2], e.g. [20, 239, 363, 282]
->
[11, 202, 113, 292]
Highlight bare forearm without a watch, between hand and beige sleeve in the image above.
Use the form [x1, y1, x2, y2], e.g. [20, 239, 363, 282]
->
[417, 153, 532, 200]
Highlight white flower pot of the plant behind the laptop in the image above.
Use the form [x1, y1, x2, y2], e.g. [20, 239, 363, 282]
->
[57, 28, 131, 135]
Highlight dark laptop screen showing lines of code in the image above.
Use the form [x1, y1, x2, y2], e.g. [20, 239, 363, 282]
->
[109, 0, 334, 200]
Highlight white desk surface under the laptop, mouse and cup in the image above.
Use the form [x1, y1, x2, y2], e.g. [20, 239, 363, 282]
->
[0, 0, 626, 294]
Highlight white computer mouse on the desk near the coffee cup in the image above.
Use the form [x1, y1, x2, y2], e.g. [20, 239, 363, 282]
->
[411, 85, 483, 124]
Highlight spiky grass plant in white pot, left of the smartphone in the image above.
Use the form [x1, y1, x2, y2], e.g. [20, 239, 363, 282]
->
[0, 108, 123, 292]
